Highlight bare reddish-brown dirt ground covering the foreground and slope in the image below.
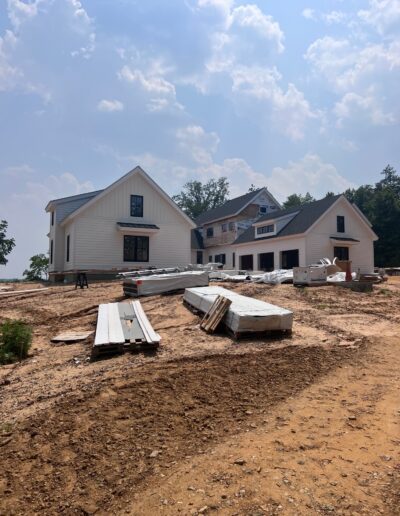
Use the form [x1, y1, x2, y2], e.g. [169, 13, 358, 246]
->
[0, 278, 400, 516]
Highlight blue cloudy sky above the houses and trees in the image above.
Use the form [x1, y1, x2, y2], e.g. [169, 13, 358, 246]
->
[0, 0, 400, 278]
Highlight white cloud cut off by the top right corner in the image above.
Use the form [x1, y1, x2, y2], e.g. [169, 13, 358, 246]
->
[358, 0, 400, 35]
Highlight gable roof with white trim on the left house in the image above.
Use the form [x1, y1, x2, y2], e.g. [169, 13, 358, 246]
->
[46, 166, 195, 228]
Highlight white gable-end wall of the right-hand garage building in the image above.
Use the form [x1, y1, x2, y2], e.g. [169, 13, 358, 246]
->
[306, 199, 374, 273]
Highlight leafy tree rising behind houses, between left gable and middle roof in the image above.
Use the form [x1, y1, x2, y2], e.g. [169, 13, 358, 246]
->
[172, 177, 229, 219]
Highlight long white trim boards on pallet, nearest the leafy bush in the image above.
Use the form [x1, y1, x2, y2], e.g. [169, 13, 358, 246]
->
[92, 301, 161, 357]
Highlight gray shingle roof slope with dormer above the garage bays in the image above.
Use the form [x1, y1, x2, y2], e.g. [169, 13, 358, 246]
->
[234, 195, 340, 244]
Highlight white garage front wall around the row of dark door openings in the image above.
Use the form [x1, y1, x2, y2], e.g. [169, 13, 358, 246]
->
[232, 236, 306, 270]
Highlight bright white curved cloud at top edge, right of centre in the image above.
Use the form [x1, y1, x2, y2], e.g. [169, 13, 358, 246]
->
[228, 4, 285, 52]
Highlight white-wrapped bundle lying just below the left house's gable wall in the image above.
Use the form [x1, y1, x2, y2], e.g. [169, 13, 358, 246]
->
[123, 271, 208, 297]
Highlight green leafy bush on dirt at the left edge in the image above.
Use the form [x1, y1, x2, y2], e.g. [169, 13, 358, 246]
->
[0, 320, 32, 364]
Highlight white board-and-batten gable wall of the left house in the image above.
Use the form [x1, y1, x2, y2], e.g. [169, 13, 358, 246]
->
[71, 174, 191, 270]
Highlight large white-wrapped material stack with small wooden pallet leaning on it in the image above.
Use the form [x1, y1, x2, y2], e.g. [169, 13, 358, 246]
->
[183, 287, 293, 338]
